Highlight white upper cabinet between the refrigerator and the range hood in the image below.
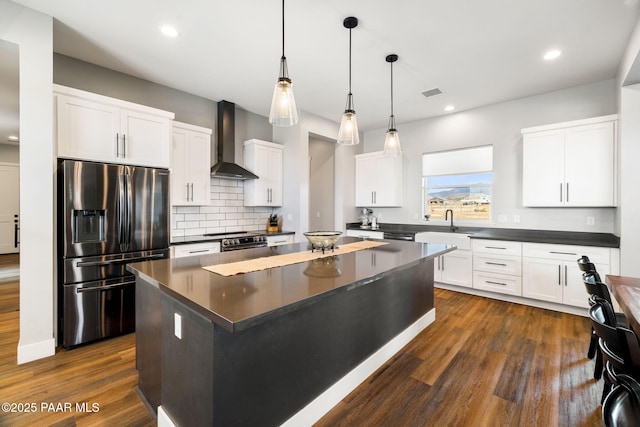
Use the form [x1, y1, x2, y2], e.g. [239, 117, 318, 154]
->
[171, 122, 212, 206]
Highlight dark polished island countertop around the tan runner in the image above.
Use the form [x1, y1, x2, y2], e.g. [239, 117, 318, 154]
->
[127, 237, 455, 332]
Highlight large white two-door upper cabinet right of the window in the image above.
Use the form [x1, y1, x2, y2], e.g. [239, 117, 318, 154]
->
[522, 115, 617, 207]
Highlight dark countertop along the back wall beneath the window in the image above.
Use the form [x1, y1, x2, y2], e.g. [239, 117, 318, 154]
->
[347, 223, 620, 248]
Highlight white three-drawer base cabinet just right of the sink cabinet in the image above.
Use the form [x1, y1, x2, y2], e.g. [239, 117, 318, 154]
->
[472, 240, 522, 296]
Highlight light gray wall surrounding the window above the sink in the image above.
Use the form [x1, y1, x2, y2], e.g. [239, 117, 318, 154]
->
[362, 80, 617, 233]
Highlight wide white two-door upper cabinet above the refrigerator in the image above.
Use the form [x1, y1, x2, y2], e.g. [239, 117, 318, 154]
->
[54, 85, 174, 168]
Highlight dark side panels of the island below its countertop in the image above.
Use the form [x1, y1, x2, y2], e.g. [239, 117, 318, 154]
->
[151, 259, 434, 426]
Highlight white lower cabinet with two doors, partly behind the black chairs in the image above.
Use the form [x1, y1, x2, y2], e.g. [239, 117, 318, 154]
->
[522, 243, 611, 308]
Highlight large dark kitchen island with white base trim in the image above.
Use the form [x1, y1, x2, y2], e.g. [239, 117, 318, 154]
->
[128, 237, 455, 426]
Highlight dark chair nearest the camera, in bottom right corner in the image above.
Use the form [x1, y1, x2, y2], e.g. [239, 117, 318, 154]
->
[602, 374, 640, 427]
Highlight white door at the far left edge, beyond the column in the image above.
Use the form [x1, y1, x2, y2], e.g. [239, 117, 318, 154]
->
[0, 165, 20, 254]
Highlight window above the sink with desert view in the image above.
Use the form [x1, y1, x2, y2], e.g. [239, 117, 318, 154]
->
[422, 146, 493, 221]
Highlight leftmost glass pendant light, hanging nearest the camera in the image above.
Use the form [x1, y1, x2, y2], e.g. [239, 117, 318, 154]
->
[269, 0, 298, 126]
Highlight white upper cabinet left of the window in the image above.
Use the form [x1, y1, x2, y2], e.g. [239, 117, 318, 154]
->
[355, 151, 402, 207]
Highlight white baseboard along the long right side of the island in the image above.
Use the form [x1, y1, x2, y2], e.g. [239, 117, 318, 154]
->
[280, 308, 436, 427]
